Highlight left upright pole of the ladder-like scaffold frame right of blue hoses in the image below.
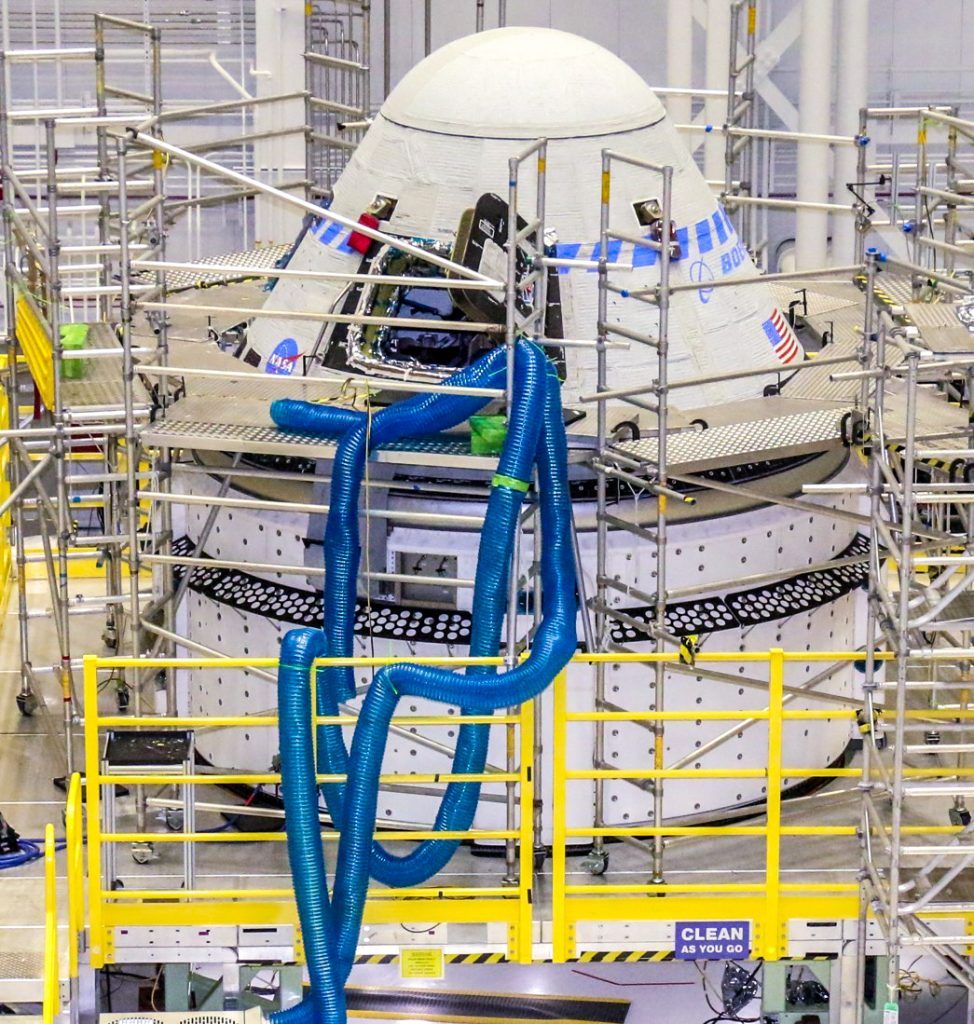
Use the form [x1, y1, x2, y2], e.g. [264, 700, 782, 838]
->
[592, 150, 612, 872]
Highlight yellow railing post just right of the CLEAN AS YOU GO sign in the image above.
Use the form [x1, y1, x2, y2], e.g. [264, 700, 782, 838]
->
[755, 647, 788, 961]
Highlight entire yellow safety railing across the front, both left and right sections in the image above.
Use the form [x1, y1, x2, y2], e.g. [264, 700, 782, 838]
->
[77, 649, 974, 966]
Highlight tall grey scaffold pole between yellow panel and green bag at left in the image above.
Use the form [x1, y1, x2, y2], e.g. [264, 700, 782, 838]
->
[44, 119, 75, 776]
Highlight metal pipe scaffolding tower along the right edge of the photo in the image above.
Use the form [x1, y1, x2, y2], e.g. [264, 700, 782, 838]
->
[841, 243, 974, 1004]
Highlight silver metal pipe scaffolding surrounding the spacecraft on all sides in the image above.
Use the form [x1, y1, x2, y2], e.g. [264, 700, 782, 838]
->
[0, 0, 974, 1019]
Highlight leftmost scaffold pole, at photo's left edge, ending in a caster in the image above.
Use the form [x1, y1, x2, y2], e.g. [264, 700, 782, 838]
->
[0, 51, 37, 715]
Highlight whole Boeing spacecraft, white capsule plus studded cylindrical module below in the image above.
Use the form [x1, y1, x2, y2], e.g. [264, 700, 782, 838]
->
[175, 28, 863, 843]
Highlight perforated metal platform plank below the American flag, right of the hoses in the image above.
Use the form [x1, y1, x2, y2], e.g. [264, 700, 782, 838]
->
[613, 404, 848, 473]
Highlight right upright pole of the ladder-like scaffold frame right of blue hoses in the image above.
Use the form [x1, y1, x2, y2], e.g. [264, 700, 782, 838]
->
[652, 166, 673, 883]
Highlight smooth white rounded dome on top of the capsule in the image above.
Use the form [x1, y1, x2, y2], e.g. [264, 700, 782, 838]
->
[381, 28, 666, 139]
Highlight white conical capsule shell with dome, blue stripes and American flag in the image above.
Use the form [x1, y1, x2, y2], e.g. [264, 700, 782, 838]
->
[250, 28, 802, 408]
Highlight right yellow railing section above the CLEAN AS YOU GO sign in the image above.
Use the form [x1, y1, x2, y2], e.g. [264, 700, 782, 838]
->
[552, 649, 974, 962]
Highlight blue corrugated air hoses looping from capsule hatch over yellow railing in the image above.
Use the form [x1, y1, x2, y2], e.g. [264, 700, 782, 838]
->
[270, 341, 577, 1024]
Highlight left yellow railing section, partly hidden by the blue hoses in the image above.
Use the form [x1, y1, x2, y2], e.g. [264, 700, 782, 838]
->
[84, 655, 534, 968]
